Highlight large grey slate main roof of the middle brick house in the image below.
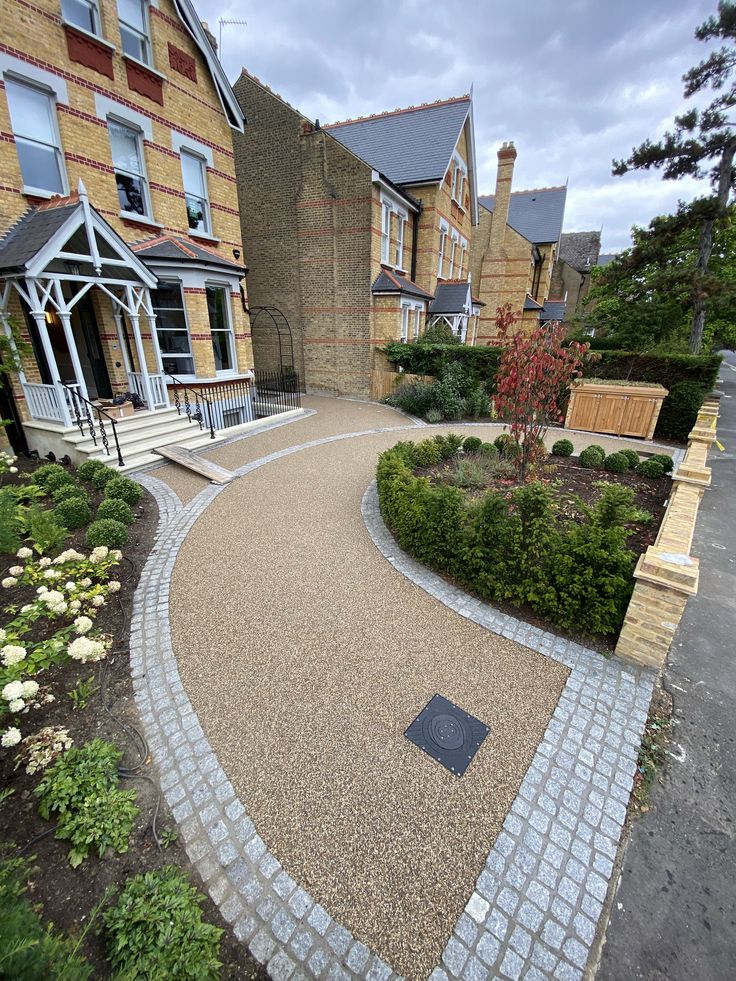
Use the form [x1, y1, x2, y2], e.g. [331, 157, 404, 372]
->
[323, 95, 470, 185]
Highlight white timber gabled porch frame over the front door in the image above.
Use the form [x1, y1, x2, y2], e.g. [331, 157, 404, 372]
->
[0, 181, 169, 427]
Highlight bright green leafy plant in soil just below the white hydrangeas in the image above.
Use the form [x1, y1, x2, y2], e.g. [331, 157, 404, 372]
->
[34, 739, 138, 868]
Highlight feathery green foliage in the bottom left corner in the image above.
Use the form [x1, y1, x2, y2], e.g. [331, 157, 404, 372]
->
[0, 858, 93, 981]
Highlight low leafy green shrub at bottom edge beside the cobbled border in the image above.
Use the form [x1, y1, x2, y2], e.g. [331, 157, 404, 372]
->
[103, 865, 223, 981]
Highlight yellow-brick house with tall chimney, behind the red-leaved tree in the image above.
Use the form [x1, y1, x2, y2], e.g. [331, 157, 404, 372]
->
[470, 143, 567, 345]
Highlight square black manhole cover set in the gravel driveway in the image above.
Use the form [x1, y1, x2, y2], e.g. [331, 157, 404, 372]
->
[404, 695, 489, 777]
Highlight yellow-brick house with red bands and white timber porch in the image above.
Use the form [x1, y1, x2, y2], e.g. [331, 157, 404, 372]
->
[0, 0, 253, 466]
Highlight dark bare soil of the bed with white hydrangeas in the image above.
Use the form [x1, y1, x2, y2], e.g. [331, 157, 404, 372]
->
[0, 461, 267, 981]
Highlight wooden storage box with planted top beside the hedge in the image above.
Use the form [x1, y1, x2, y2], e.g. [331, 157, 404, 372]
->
[565, 379, 667, 439]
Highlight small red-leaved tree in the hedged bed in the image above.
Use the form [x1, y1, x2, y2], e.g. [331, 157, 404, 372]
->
[494, 303, 589, 481]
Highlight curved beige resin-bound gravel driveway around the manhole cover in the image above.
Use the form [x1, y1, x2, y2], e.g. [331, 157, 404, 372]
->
[138, 398, 651, 978]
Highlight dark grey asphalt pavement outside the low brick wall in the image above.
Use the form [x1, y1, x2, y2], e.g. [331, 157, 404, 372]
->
[596, 352, 736, 981]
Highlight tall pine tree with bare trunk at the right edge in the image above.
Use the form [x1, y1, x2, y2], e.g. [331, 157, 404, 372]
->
[613, 0, 736, 354]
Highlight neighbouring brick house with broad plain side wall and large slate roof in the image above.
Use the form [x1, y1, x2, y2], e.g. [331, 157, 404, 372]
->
[234, 70, 480, 398]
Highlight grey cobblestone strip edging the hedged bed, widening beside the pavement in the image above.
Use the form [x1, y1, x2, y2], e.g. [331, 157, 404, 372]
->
[363, 482, 655, 981]
